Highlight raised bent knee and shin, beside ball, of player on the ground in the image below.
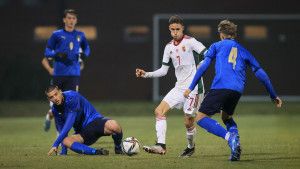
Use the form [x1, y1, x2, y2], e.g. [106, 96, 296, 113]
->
[104, 120, 123, 154]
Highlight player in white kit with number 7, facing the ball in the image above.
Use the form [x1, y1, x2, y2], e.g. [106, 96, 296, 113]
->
[136, 15, 206, 157]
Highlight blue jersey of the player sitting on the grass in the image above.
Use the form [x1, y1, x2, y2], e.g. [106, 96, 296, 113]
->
[52, 91, 103, 147]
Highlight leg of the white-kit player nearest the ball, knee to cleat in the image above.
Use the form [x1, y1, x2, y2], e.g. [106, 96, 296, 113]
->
[143, 101, 170, 155]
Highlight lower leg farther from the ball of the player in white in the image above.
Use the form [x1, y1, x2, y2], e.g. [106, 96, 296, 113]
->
[180, 114, 196, 157]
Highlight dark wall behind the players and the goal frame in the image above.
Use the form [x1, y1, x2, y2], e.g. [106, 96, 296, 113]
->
[0, 0, 300, 101]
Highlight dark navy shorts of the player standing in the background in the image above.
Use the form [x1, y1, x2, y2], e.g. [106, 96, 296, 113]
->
[52, 76, 80, 91]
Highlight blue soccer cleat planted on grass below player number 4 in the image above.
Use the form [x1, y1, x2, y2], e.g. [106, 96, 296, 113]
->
[228, 133, 241, 161]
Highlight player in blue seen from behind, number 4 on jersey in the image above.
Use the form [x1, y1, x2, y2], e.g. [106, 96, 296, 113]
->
[184, 20, 282, 161]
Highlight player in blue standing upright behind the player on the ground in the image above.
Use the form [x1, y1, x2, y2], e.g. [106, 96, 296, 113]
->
[42, 9, 90, 131]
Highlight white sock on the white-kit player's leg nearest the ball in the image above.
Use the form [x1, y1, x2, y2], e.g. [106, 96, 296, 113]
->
[155, 118, 167, 144]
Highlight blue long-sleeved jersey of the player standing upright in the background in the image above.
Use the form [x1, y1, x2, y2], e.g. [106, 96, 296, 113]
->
[45, 29, 90, 76]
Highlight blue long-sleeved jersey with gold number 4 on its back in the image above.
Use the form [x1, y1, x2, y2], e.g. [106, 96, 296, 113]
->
[189, 39, 277, 99]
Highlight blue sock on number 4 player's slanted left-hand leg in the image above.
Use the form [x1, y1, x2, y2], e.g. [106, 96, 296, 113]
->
[197, 117, 227, 139]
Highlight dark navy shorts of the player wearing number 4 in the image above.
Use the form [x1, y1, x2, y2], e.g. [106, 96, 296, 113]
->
[199, 89, 241, 116]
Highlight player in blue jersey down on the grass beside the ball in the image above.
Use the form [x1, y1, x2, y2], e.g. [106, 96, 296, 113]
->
[45, 85, 123, 155]
